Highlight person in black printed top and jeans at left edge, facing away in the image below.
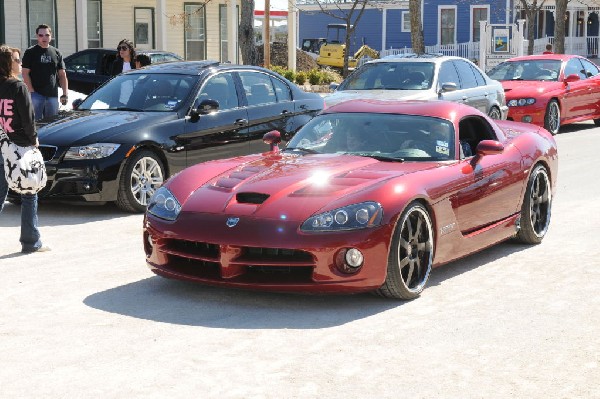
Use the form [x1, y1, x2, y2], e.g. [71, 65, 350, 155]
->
[0, 45, 50, 253]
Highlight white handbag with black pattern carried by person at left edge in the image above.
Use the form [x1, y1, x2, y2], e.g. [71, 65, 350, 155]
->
[0, 129, 48, 194]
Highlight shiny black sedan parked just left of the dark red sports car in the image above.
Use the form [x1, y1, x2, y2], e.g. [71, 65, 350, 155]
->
[17, 61, 323, 212]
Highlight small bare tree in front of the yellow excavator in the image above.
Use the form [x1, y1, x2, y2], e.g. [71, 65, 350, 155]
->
[315, 0, 372, 76]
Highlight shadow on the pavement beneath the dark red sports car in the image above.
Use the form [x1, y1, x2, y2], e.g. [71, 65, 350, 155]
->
[84, 243, 528, 329]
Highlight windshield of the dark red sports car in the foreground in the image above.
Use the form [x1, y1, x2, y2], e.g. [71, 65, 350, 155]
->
[285, 113, 455, 161]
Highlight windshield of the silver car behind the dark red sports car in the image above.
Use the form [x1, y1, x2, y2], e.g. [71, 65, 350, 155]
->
[338, 62, 435, 90]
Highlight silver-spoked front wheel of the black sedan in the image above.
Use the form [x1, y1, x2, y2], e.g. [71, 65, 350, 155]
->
[117, 150, 165, 212]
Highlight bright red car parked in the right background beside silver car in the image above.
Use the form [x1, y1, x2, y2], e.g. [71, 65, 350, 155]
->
[490, 54, 600, 134]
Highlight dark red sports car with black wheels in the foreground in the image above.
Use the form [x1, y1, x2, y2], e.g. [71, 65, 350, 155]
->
[143, 99, 558, 299]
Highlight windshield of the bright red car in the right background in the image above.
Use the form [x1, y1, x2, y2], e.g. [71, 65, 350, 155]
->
[488, 59, 561, 81]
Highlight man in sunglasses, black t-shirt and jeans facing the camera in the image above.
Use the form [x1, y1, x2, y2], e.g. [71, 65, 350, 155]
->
[23, 24, 69, 120]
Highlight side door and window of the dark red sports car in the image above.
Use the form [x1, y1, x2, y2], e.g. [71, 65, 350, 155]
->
[451, 116, 527, 234]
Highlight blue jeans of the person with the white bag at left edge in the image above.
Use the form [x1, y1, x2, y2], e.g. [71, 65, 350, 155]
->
[0, 153, 42, 252]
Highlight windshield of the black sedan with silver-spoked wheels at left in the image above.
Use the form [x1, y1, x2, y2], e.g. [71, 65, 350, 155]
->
[77, 73, 198, 112]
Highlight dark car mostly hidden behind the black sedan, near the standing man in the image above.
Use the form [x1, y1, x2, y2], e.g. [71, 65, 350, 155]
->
[65, 48, 183, 94]
